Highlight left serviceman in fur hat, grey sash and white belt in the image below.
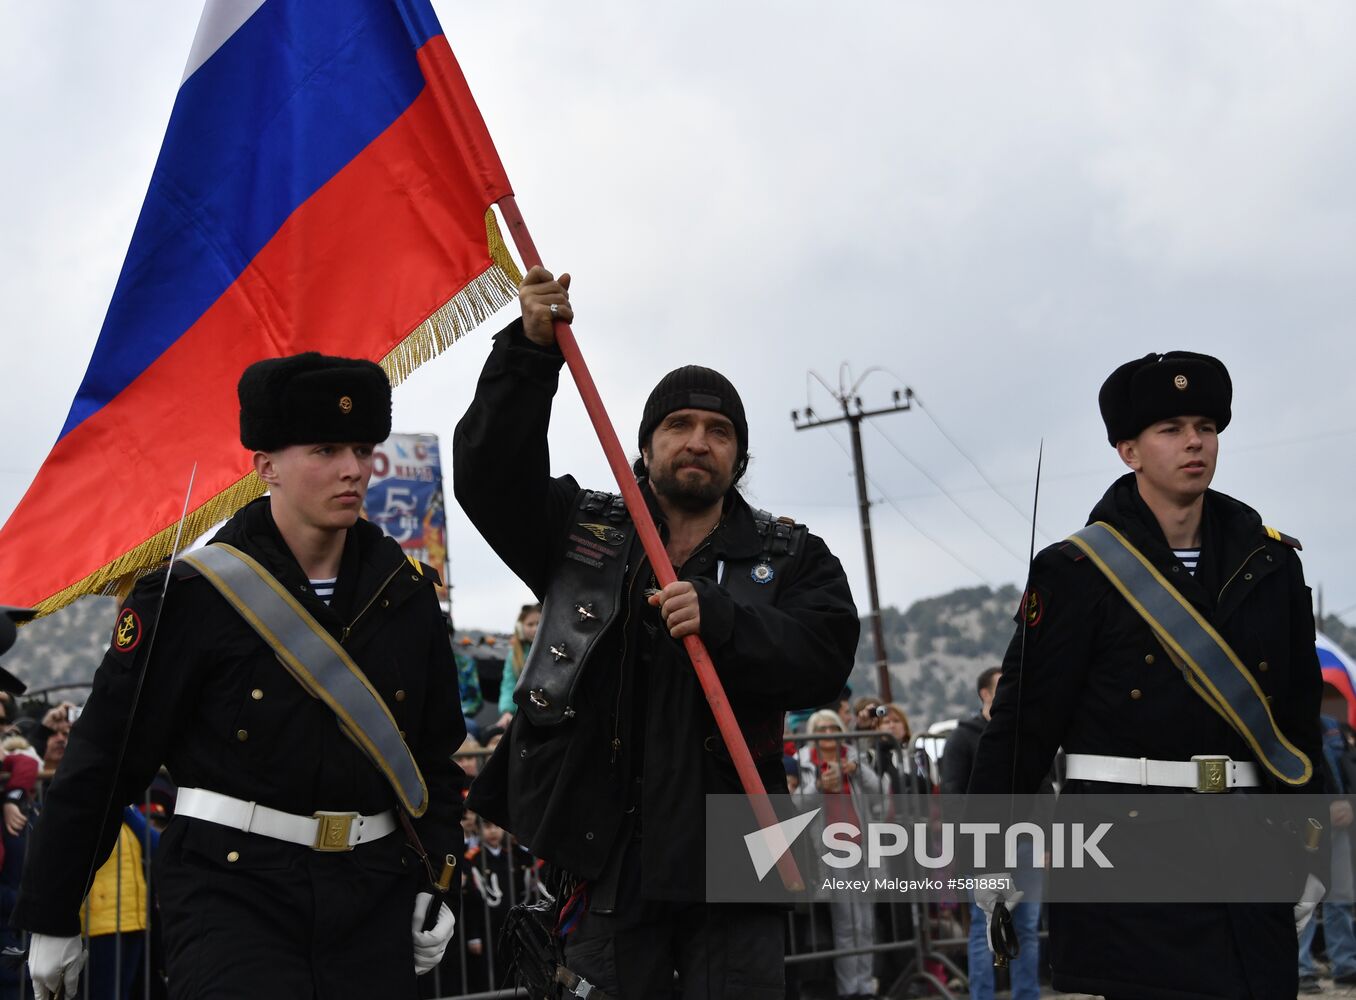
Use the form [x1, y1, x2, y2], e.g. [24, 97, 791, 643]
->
[14, 353, 465, 1000]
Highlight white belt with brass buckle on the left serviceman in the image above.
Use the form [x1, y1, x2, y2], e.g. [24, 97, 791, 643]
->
[174, 788, 396, 851]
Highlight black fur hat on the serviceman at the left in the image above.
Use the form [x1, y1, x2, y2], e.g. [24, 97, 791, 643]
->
[237, 351, 391, 452]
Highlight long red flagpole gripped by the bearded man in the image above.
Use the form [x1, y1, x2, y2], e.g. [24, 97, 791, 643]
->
[498, 194, 804, 890]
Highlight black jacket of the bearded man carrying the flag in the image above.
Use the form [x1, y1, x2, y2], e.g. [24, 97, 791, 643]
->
[453, 322, 860, 900]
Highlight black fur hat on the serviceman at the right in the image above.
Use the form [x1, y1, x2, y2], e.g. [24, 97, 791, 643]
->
[1097, 350, 1234, 445]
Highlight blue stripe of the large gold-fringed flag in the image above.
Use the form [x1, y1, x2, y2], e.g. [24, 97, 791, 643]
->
[61, 0, 441, 436]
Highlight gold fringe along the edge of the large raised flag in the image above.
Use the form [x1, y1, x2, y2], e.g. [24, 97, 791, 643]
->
[34, 209, 522, 617]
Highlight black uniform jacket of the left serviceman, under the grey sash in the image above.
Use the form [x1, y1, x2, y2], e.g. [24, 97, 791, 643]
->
[14, 498, 465, 935]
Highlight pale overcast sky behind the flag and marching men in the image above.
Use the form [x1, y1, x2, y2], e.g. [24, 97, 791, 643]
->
[0, 0, 1356, 628]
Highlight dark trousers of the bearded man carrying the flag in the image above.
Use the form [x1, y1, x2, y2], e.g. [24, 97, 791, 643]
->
[565, 841, 786, 1000]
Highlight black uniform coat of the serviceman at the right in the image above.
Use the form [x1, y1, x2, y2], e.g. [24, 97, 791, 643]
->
[970, 474, 1322, 1000]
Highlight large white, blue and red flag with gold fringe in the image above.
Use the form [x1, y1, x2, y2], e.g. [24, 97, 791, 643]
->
[0, 0, 519, 612]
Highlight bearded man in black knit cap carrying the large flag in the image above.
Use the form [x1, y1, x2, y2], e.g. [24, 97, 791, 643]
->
[453, 267, 858, 1000]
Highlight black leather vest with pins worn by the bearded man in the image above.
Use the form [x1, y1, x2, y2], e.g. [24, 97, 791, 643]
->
[513, 490, 807, 727]
